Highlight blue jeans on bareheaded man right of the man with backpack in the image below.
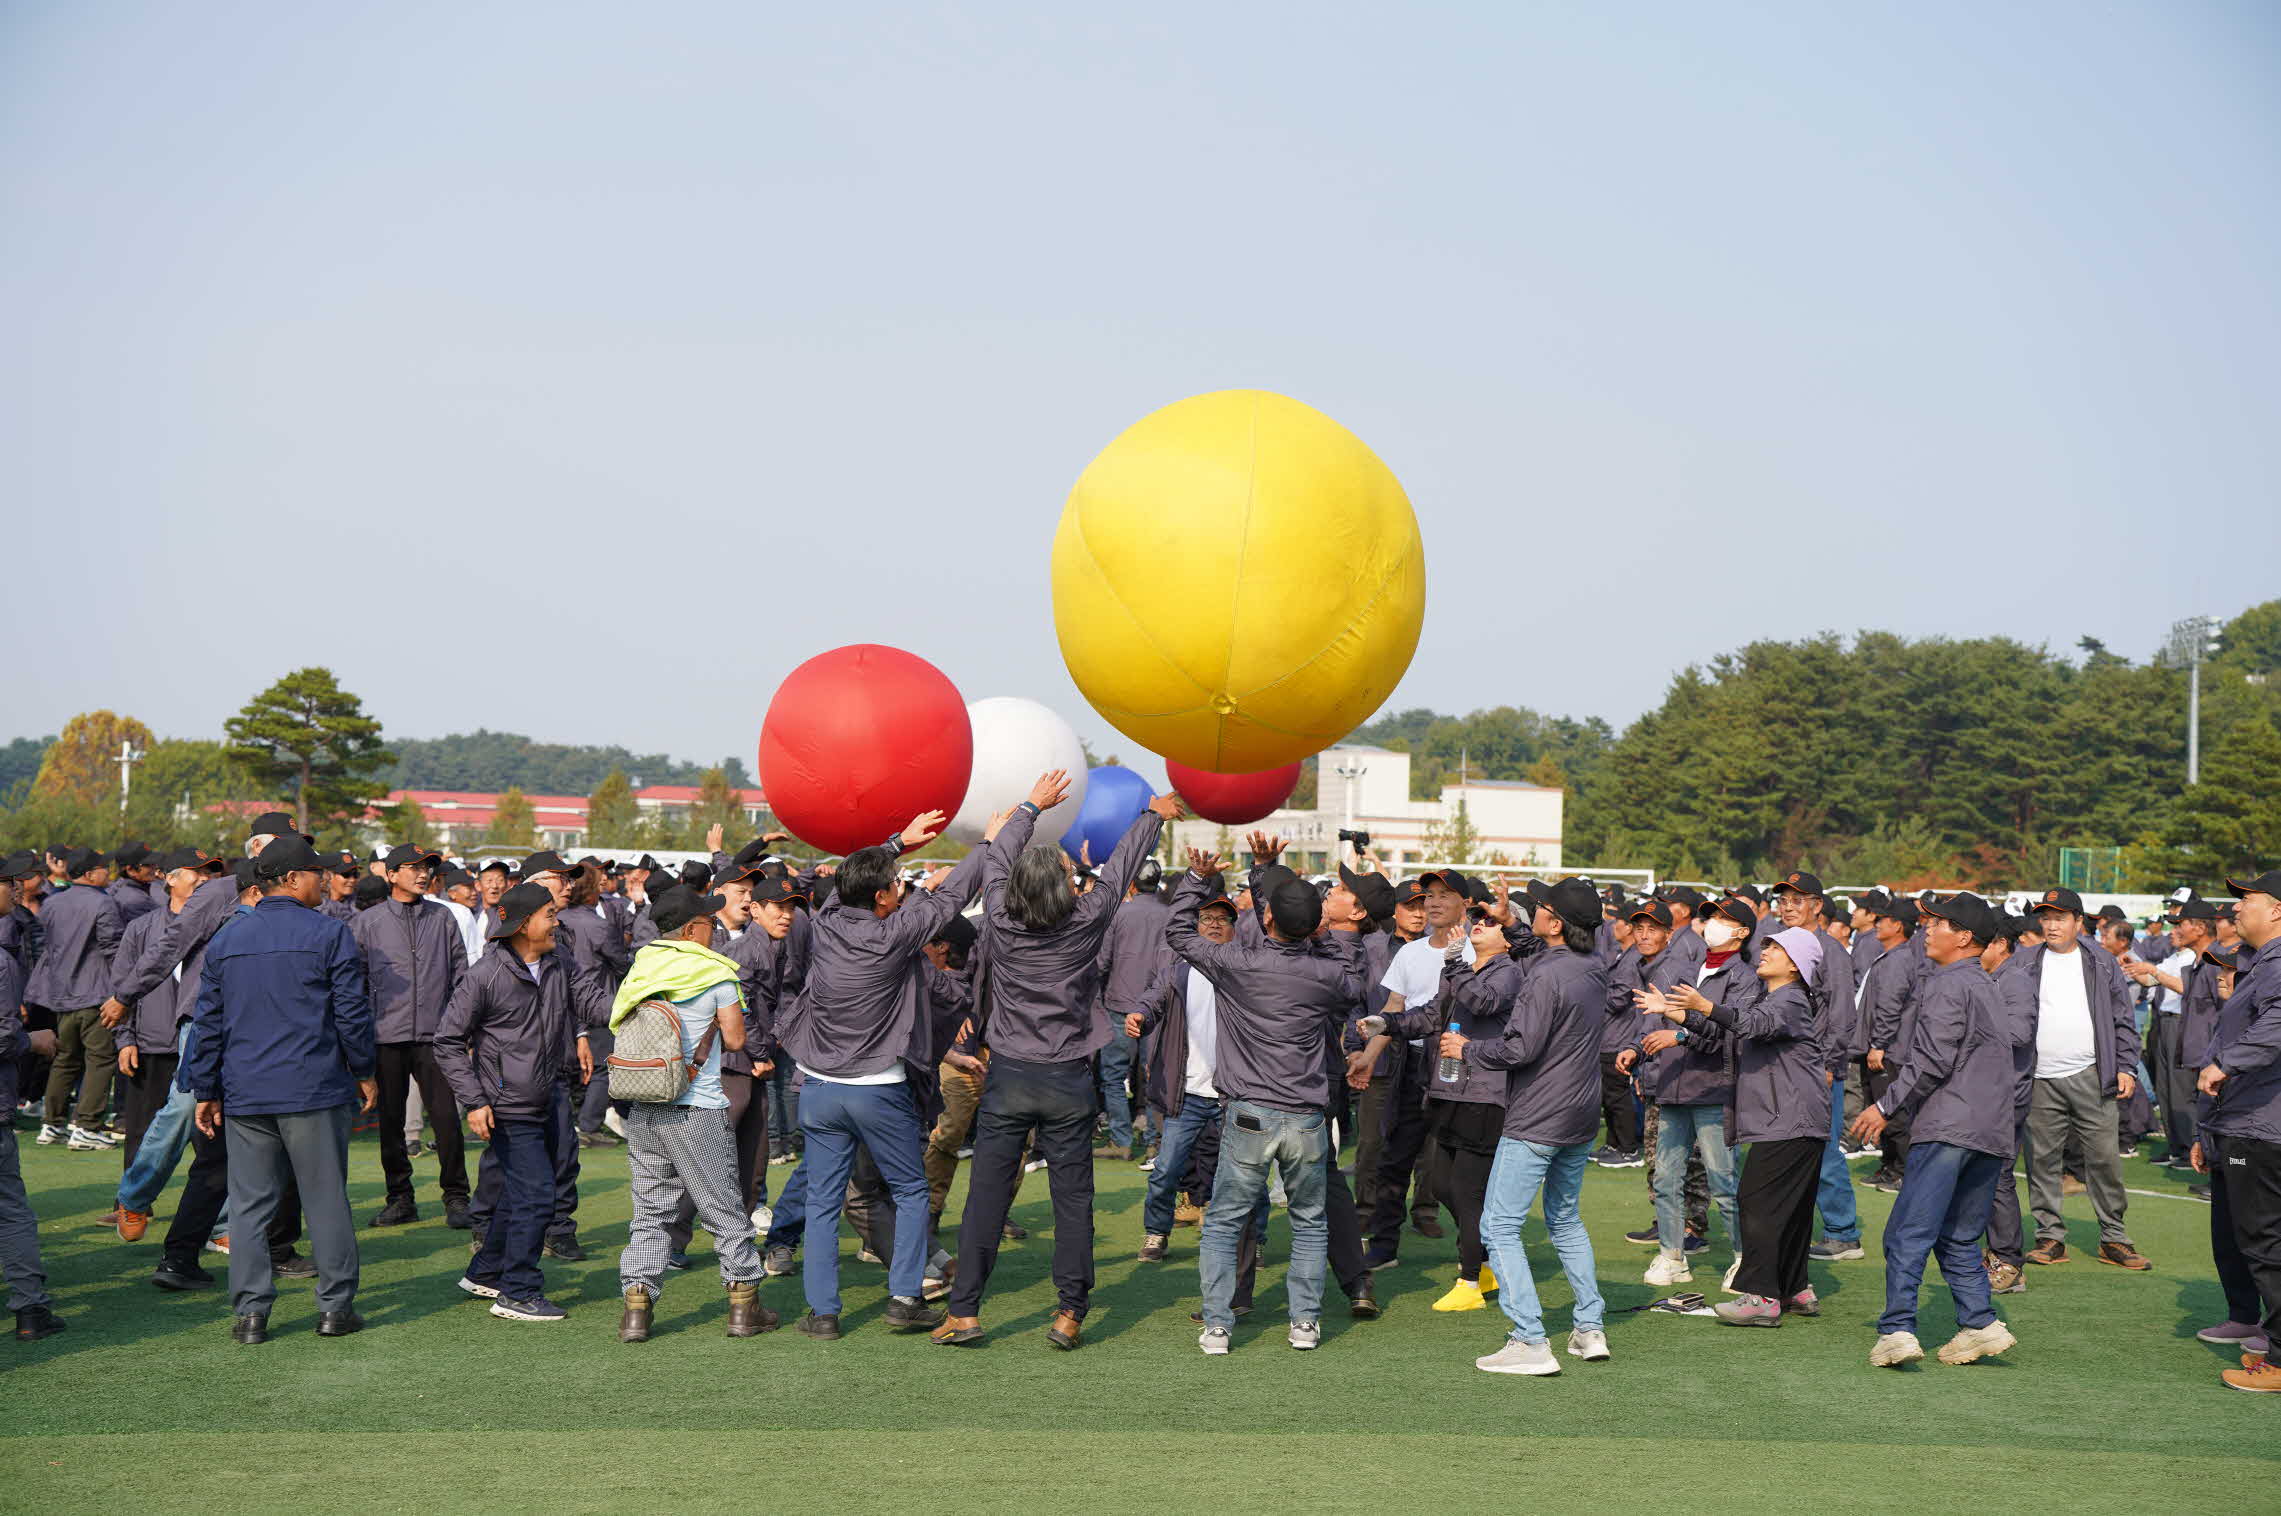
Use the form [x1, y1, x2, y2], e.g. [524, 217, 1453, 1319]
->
[787, 1078, 928, 1315]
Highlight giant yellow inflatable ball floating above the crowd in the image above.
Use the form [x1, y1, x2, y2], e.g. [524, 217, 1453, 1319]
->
[1054, 390, 1426, 773]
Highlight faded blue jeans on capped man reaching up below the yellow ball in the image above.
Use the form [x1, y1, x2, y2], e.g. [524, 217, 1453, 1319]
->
[1204, 1101, 1330, 1331]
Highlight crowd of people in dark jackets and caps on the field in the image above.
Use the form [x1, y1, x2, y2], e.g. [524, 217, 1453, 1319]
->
[0, 797, 2281, 1393]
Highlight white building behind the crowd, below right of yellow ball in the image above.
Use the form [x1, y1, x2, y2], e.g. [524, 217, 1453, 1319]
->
[1175, 743, 1565, 878]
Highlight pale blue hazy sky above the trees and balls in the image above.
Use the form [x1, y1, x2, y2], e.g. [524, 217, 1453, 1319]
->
[0, 0, 2281, 793]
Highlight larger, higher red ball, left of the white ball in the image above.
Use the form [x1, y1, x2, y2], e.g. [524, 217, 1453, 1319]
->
[760, 643, 974, 853]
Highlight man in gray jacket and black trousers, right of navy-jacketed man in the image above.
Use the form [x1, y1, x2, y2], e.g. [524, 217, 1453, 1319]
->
[347, 843, 468, 1231]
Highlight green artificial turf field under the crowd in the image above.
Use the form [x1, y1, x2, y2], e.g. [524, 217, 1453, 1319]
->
[0, 1133, 2281, 1516]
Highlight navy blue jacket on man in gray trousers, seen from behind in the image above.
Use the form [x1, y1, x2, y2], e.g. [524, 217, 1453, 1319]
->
[189, 896, 374, 1115]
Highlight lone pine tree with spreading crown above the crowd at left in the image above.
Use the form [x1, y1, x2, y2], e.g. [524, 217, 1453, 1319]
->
[224, 668, 395, 834]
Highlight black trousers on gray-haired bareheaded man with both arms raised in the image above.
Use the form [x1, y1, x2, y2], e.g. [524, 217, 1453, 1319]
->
[949, 1053, 1099, 1320]
